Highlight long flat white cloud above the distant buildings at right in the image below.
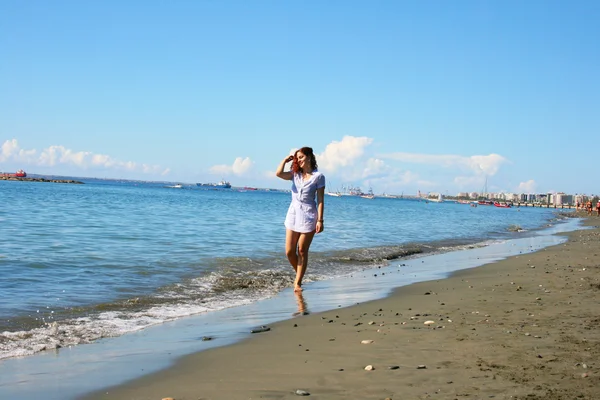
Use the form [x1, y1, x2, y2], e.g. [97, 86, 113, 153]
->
[381, 152, 509, 176]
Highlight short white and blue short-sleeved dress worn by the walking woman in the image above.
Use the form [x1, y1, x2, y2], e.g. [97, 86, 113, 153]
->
[285, 171, 325, 233]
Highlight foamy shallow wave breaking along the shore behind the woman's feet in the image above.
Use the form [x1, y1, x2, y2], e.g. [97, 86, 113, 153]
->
[0, 241, 494, 359]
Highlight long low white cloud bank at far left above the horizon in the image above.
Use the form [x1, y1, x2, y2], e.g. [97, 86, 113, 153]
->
[0, 139, 169, 174]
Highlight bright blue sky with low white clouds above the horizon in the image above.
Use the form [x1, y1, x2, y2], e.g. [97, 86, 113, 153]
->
[0, 0, 600, 194]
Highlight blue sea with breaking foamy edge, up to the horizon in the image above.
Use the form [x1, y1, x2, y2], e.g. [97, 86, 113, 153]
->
[0, 179, 559, 359]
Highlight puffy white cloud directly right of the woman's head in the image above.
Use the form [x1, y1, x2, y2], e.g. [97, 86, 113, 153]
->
[317, 136, 373, 172]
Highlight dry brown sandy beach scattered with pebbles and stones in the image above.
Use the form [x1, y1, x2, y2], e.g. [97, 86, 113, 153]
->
[85, 217, 600, 400]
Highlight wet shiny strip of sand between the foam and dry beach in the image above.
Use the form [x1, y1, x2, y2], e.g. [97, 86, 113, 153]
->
[0, 218, 596, 400]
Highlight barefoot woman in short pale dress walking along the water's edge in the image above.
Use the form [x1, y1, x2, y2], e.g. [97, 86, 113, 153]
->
[276, 147, 325, 292]
